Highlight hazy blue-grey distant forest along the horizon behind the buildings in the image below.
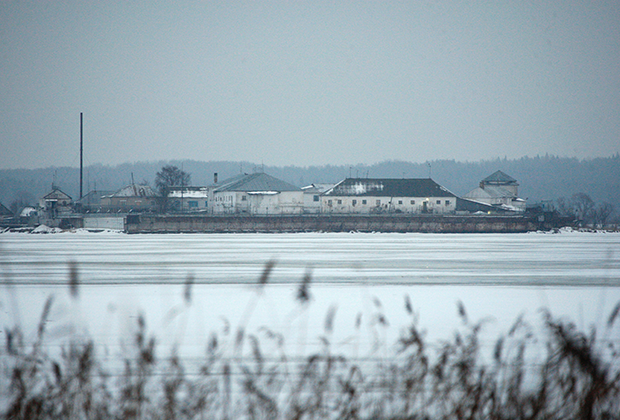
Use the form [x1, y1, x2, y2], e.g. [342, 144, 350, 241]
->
[0, 153, 620, 218]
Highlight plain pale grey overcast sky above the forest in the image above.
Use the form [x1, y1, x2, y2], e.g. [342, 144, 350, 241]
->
[0, 0, 620, 168]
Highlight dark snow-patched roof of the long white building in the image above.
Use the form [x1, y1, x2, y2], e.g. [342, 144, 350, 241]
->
[325, 178, 455, 197]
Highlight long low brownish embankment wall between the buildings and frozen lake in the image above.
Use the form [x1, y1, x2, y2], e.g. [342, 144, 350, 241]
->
[125, 215, 553, 233]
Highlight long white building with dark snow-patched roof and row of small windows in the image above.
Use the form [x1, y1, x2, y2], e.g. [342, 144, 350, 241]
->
[321, 178, 457, 214]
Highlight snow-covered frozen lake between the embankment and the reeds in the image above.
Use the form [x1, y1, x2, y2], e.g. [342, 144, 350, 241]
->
[0, 231, 620, 364]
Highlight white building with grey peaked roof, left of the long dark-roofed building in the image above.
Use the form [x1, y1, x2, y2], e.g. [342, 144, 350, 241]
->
[210, 172, 304, 215]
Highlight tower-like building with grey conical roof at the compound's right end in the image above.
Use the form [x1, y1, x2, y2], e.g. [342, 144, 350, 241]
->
[463, 171, 526, 212]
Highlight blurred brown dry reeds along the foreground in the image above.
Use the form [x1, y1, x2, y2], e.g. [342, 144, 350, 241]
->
[0, 262, 620, 420]
